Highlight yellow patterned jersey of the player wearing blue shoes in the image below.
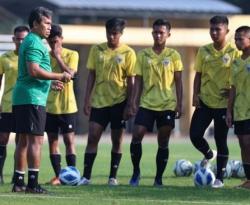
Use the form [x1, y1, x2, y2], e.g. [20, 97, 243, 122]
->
[135, 48, 183, 111]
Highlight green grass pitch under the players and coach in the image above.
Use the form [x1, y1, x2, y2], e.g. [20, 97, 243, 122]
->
[0, 139, 250, 205]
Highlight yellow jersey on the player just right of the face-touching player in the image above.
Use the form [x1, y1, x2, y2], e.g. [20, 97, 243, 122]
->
[87, 43, 136, 108]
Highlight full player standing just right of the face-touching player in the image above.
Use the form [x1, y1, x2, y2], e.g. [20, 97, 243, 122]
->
[79, 18, 136, 185]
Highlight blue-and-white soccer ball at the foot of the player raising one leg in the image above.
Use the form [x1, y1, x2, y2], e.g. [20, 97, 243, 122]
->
[194, 168, 215, 187]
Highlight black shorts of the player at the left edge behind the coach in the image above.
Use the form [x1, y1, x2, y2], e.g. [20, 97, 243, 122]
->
[0, 112, 15, 132]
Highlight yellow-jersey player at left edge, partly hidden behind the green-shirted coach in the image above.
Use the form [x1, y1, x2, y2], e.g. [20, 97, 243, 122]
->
[0, 26, 29, 184]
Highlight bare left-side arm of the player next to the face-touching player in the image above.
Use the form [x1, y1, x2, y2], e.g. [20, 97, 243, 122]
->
[83, 70, 96, 116]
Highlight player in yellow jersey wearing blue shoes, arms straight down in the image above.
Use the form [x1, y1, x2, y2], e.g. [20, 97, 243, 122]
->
[129, 19, 183, 187]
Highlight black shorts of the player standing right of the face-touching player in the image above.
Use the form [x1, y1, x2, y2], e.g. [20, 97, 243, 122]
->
[89, 101, 126, 129]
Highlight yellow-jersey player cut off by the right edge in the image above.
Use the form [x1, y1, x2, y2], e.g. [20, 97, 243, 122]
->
[226, 26, 250, 189]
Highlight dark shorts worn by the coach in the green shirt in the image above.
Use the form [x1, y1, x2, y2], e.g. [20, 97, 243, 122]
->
[12, 105, 46, 136]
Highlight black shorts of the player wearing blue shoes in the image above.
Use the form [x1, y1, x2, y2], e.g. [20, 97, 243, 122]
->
[134, 107, 175, 132]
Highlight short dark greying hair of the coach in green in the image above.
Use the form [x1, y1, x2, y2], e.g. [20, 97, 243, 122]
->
[29, 6, 52, 28]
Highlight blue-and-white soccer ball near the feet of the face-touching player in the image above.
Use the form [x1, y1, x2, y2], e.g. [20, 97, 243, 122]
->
[59, 166, 81, 186]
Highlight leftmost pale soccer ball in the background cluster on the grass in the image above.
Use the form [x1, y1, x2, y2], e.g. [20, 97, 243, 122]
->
[173, 159, 193, 177]
